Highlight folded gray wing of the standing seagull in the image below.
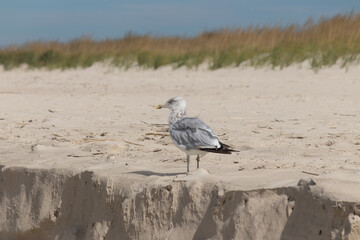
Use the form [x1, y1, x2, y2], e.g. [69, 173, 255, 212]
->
[170, 117, 221, 149]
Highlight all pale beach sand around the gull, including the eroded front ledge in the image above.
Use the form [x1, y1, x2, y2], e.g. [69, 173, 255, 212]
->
[0, 64, 360, 240]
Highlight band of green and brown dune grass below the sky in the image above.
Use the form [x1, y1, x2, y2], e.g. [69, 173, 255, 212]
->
[0, 13, 360, 70]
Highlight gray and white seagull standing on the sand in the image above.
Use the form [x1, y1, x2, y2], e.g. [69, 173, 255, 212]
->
[156, 97, 238, 172]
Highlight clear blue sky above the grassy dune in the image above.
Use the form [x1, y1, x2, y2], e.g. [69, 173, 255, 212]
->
[0, 0, 360, 46]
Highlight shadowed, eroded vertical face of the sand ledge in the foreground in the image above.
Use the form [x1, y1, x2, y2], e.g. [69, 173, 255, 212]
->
[0, 167, 360, 239]
